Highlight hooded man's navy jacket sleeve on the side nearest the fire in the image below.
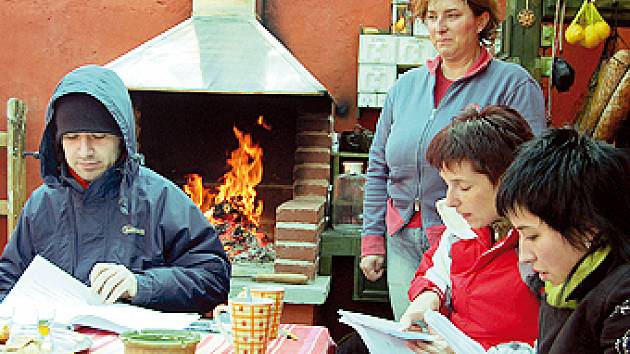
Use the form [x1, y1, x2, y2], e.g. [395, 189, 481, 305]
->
[132, 190, 231, 313]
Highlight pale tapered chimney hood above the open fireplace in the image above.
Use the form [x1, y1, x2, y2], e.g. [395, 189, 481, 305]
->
[106, 0, 327, 96]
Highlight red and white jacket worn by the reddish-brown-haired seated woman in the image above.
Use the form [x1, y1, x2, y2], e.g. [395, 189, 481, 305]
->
[408, 202, 539, 350]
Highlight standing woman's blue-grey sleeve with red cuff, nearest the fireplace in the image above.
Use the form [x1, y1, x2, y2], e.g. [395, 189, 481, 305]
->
[361, 94, 393, 256]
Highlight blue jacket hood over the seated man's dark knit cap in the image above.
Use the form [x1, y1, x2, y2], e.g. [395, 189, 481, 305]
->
[39, 65, 142, 185]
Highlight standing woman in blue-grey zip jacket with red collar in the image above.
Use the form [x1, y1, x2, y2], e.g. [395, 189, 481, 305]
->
[360, 0, 546, 320]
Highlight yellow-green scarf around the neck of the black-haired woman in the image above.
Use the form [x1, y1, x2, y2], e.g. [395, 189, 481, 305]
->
[545, 246, 610, 309]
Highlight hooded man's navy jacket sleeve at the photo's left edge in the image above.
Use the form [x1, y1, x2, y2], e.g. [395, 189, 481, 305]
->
[0, 199, 35, 301]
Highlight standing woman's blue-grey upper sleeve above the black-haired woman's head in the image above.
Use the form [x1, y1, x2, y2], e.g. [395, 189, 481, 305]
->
[504, 73, 547, 135]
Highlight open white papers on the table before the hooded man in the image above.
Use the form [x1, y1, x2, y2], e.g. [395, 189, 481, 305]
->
[0, 255, 201, 333]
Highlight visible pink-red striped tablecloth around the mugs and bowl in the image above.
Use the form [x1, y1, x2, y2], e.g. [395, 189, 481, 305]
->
[78, 324, 335, 354]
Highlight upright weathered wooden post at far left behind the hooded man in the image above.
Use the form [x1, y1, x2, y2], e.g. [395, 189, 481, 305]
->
[4, 98, 26, 240]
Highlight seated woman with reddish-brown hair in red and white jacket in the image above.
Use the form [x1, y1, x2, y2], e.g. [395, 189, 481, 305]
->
[401, 106, 539, 353]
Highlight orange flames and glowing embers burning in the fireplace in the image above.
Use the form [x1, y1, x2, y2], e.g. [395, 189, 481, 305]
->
[183, 121, 275, 262]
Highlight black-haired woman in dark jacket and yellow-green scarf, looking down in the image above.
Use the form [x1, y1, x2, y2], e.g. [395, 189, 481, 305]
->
[497, 128, 630, 354]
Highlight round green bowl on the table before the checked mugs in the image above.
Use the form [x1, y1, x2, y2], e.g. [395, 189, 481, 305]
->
[120, 329, 201, 353]
